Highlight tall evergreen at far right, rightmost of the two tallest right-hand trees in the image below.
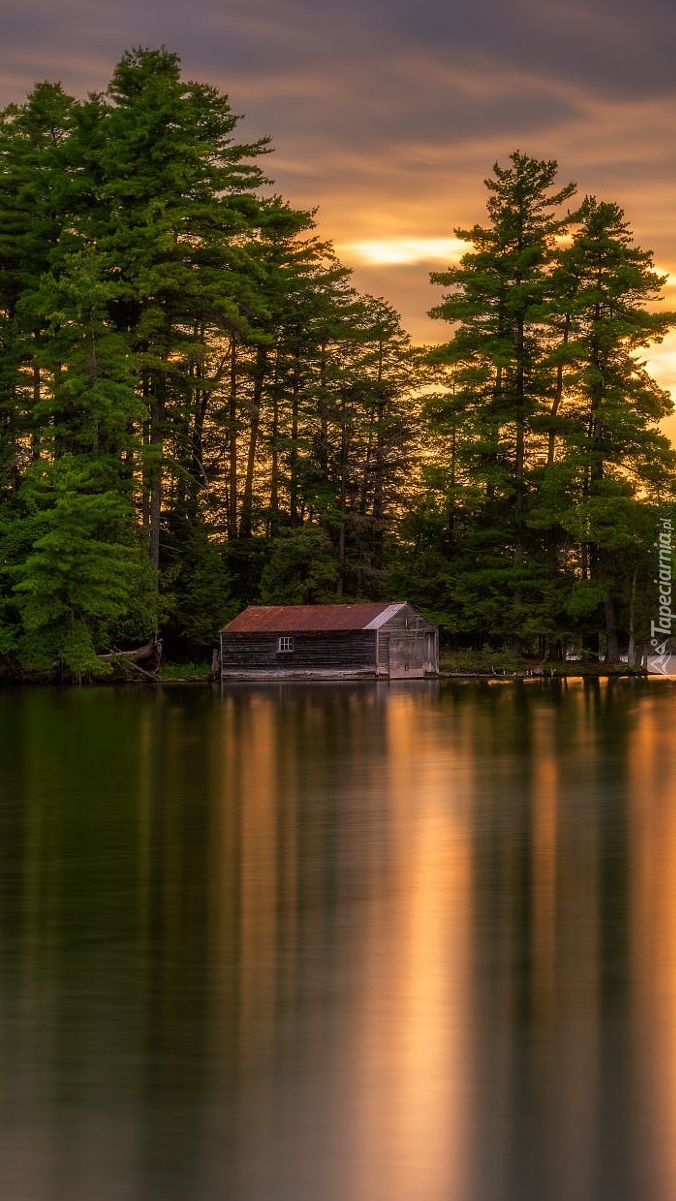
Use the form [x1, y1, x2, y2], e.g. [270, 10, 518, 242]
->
[554, 197, 676, 661]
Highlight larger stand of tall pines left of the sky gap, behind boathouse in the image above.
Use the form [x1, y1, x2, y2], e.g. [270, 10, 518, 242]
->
[0, 50, 415, 675]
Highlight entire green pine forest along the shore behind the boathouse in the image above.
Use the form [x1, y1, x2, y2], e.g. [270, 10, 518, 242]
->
[0, 49, 676, 677]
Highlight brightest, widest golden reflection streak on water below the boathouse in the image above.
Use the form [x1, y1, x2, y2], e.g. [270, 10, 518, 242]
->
[352, 692, 471, 1201]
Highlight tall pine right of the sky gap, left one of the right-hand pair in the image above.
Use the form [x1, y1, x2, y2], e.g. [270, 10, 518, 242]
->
[431, 151, 575, 646]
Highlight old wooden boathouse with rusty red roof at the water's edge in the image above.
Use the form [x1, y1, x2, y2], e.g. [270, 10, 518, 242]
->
[220, 601, 438, 680]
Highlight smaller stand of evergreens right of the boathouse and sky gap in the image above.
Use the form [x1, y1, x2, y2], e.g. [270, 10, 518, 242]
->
[391, 153, 676, 661]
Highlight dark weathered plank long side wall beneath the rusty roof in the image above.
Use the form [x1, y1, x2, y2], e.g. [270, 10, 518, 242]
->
[221, 629, 376, 677]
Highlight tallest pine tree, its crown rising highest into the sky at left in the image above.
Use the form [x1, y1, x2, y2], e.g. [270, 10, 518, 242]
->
[78, 49, 267, 581]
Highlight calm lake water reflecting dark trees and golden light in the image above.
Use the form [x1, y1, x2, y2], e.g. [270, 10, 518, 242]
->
[0, 681, 676, 1201]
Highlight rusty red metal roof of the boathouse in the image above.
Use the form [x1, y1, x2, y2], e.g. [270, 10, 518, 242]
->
[220, 601, 405, 634]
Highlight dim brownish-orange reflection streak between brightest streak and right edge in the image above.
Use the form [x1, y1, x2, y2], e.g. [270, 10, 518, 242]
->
[531, 711, 599, 1199]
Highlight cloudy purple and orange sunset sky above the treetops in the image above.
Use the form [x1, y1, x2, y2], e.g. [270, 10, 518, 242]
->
[0, 0, 676, 410]
